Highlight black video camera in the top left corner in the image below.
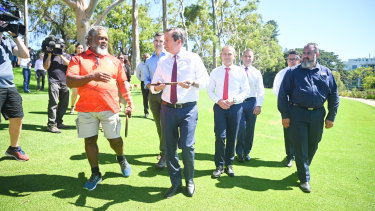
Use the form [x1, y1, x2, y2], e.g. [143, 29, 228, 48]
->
[0, 0, 26, 35]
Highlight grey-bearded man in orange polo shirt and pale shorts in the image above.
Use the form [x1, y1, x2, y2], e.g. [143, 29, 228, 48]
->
[66, 26, 134, 190]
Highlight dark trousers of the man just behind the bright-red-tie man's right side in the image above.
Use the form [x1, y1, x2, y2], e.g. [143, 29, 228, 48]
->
[236, 97, 257, 155]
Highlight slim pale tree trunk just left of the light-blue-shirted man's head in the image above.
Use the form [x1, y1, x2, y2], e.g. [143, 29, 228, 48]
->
[132, 0, 140, 70]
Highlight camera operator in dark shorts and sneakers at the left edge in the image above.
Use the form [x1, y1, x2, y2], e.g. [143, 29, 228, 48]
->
[0, 21, 29, 161]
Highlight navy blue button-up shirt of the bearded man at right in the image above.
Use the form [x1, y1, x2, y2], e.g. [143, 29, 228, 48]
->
[277, 63, 339, 122]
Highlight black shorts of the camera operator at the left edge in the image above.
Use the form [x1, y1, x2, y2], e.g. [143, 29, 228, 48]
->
[0, 87, 23, 121]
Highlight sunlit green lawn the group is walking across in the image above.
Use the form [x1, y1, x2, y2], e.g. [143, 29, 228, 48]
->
[0, 69, 375, 210]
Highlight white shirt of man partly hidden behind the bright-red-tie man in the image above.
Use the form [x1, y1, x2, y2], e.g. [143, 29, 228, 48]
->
[245, 65, 265, 106]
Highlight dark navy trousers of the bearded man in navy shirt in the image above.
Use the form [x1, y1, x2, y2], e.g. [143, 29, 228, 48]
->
[290, 107, 326, 183]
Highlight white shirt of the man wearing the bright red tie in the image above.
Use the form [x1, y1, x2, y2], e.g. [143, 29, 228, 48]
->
[207, 64, 250, 104]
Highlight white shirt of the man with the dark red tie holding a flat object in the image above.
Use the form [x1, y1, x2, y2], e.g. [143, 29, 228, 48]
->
[150, 49, 209, 104]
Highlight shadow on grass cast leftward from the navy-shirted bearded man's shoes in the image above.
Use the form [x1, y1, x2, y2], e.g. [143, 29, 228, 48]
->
[216, 172, 298, 191]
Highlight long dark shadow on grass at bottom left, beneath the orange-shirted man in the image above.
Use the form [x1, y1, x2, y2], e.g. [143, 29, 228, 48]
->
[0, 172, 166, 210]
